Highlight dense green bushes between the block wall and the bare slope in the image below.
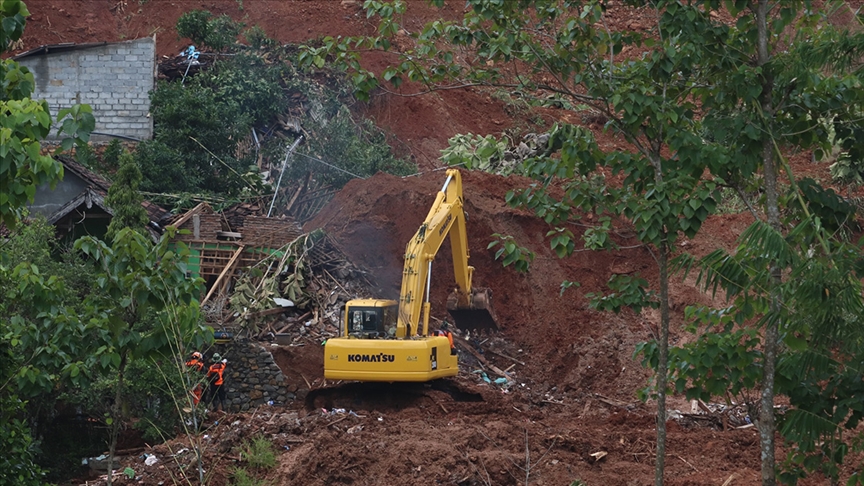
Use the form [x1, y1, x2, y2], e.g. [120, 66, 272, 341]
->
[135, 11, 414, 211]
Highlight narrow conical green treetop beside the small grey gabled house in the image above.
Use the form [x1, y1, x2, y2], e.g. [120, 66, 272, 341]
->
[105, 153, 150, 240]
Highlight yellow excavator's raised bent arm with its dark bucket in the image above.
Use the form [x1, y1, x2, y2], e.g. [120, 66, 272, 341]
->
[396, 169, 497, 338]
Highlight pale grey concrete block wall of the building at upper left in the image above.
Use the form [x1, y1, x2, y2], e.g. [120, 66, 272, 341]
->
[18, 37, 156, 140]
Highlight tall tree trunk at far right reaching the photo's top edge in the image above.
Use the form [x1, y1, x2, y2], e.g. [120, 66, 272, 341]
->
[756, 0, 782, 486]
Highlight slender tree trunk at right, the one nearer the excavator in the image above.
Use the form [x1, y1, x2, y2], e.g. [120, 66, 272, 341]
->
[654, 238, 669, 486]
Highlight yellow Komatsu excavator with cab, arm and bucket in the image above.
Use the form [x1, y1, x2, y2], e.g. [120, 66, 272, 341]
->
[324, 169, 498, 382]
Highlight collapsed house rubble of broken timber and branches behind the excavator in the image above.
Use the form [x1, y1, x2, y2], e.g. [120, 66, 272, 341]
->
[166, 203, 376, 338]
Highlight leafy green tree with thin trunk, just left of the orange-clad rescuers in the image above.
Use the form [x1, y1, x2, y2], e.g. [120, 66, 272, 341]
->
[75, 228, 212, 484]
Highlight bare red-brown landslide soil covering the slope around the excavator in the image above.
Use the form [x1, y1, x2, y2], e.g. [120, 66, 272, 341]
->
[21, 0, 860, 486]
